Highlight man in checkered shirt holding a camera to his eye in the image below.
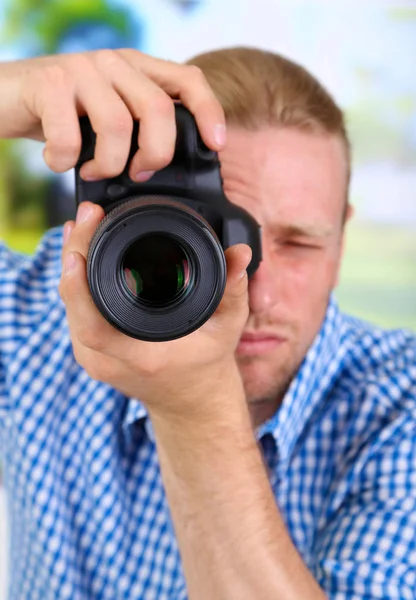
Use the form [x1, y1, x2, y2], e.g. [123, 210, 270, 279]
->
[0, 48, 416, 600]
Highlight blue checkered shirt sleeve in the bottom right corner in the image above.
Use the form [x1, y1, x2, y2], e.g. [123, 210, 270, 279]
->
[314, 411, 416, 600]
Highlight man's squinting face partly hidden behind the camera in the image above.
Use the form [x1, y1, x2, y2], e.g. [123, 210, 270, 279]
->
[220, 126, 352, 426]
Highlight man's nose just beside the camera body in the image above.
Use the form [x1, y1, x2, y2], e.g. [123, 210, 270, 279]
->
[248, 250, 280, 314]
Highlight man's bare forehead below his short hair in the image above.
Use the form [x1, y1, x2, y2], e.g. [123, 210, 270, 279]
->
[220, 126, 347, 231]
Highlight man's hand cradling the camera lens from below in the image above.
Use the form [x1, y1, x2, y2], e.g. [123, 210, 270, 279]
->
[59, 202, 251, 419]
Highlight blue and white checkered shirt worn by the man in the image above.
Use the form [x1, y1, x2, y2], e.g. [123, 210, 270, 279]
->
[0, 227, 416, 600]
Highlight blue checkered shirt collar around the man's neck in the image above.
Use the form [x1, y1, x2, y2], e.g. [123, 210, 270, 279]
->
[123, 295, 347, 454]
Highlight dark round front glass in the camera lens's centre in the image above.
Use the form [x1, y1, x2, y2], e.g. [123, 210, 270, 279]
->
[122, 233, 190, 305]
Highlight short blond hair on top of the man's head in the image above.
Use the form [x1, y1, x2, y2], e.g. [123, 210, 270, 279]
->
[186, 47, 351, 220]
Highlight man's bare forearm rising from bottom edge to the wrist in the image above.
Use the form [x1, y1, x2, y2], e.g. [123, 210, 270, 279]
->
[148, 365, 325, 600]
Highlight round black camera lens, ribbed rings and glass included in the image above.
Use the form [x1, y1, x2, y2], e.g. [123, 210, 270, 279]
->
[87, 195, 227, 342]
